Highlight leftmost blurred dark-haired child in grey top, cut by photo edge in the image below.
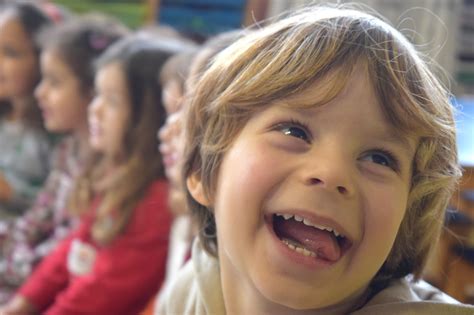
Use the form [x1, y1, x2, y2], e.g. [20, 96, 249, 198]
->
[0, 2, 51, 219]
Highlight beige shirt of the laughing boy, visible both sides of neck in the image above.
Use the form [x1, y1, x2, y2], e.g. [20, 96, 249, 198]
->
[155, 240, 474, 315]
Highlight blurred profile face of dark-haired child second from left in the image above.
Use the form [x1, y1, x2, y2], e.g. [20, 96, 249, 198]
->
[35, 50, 91, 132]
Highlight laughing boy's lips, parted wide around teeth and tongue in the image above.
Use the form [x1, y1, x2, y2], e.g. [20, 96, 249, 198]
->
[265, 210, 352, 266]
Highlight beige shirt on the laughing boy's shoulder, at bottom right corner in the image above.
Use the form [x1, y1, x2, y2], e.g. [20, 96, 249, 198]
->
[352, 277, 474, 315]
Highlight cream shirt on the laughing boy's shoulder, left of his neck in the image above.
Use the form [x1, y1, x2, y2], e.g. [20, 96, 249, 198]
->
[156, 239, 225, 315]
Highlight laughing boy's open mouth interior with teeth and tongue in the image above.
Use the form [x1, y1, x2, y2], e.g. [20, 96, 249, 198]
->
[272, 213, 352, 262]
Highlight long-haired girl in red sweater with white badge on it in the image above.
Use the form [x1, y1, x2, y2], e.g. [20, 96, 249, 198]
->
[2, 35, 180, 315]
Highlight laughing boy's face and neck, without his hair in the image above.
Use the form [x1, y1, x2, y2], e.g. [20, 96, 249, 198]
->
[188, 67, 416, 311]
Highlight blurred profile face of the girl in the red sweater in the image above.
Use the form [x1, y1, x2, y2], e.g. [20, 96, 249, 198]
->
[89, 62, 131, 158]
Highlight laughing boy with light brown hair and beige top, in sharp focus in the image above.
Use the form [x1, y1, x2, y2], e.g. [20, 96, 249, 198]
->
[160, 7, 473, 314]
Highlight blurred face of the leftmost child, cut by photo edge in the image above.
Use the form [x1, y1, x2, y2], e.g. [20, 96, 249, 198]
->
[0, 10, 39, 99]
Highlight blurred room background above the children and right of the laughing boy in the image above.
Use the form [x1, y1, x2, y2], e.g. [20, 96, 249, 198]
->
[49, 0, 474, 303]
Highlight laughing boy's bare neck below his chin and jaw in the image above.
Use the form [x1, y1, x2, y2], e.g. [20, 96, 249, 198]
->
[220, 264, 367, 315]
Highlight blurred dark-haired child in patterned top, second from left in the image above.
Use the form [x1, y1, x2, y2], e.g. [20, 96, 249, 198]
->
[0, 16, 126, 303]
